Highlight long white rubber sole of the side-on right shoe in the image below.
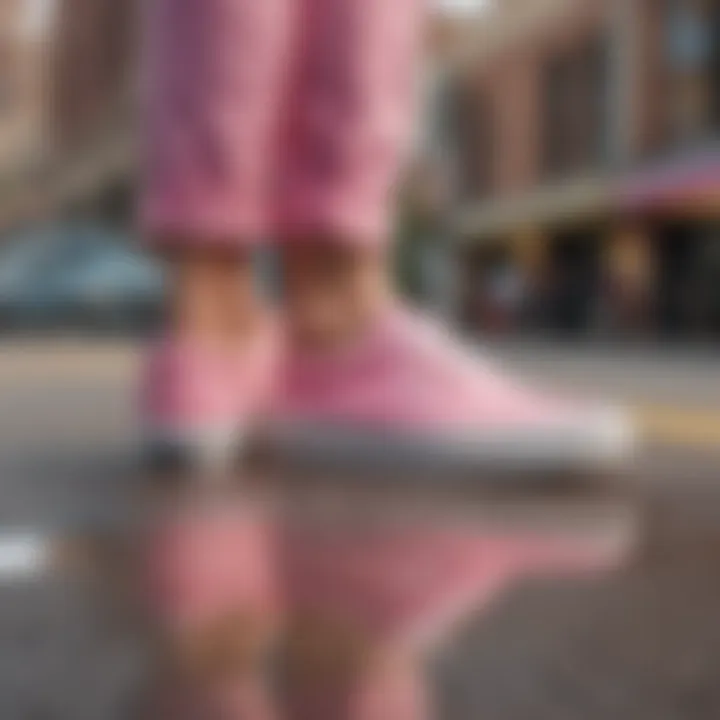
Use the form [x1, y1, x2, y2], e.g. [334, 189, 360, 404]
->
[264, 409, 637, 474]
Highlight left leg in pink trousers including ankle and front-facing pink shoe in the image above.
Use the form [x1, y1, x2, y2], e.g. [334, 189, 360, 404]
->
[140, 0, 292, 466]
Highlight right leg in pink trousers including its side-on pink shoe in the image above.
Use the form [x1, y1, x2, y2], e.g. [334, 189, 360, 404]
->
[272, 0, 632, 469]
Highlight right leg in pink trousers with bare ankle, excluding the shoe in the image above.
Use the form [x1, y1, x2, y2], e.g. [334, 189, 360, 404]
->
[278, 0, 427, 344]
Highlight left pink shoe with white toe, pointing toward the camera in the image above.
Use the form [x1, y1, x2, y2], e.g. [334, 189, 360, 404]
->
[141, 337, 273, 468]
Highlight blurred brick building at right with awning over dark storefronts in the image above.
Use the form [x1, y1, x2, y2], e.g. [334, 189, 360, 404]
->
[451, 0, 720, 337]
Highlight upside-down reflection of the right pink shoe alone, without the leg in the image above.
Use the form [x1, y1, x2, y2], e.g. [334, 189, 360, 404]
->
[284, 518, 634, 654]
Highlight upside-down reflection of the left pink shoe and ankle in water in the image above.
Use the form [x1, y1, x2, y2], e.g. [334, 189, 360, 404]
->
[146, 500, 281, 720]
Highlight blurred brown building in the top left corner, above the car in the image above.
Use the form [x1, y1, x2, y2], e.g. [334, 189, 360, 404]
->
[0, 0, 139, 230]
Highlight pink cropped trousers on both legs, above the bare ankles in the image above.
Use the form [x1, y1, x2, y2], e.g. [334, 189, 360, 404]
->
[142, 0, 425, 244]
